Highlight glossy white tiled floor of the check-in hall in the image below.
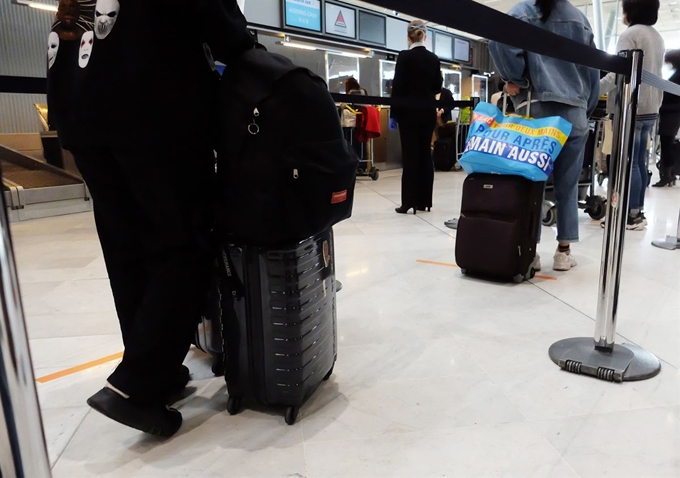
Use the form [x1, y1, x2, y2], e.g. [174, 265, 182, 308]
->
[13, 172, 680, 478]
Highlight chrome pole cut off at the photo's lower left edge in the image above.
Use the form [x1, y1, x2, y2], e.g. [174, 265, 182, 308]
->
[0, 178, 52, 478]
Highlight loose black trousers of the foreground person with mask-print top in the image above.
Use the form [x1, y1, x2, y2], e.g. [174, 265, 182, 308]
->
[73, 147, 214, 402]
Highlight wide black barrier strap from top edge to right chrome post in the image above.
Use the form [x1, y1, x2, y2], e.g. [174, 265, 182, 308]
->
[364, 0, 631, 75]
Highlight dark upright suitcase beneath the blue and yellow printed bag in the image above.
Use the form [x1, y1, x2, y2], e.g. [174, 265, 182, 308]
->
[456, 173, 545, 283]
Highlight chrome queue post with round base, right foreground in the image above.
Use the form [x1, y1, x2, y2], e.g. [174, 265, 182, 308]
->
[549, 50, 661, 382]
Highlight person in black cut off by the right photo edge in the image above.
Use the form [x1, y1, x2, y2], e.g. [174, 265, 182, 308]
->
[654, 50, 680, 188]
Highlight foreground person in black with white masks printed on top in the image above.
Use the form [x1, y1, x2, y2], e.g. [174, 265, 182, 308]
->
[48, 0, 254, 436]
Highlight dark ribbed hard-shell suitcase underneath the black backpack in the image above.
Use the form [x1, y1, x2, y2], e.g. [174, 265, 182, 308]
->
[222, 229, 337, 425]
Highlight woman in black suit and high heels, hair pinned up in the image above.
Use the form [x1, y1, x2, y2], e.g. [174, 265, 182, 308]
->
[392, 20, 442, 214]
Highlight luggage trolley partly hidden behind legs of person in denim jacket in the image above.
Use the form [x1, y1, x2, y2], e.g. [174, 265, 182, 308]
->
[543, 119, 607, 227]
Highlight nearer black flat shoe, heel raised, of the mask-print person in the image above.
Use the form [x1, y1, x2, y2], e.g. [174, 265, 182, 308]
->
[87, 388, 182, 437]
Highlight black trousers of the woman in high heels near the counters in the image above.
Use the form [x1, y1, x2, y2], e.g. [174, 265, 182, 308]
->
[399, 116, 437, 208]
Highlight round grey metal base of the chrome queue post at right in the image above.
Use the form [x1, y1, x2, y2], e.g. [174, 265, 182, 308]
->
[548, 337, 661, 382]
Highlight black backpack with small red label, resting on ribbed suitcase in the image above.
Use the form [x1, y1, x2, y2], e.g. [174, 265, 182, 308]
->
[217, 48, 358, 246]
